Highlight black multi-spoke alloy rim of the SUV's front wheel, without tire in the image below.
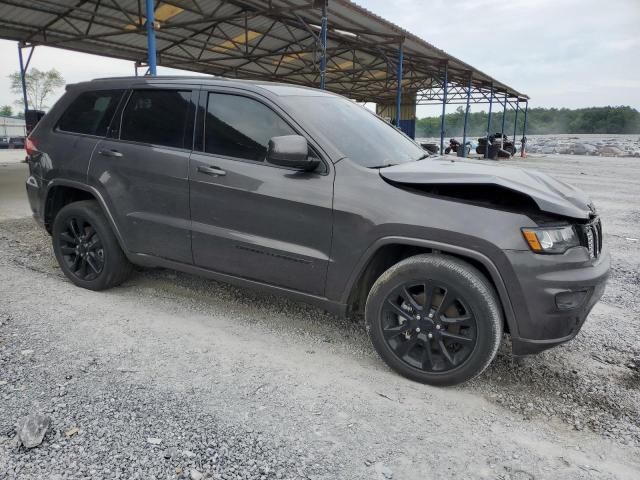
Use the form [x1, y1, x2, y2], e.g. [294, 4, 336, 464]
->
[382, 280, 477, 372]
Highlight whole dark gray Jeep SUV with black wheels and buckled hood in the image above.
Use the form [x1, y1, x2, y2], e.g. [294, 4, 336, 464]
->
[25, 77, 609, 385]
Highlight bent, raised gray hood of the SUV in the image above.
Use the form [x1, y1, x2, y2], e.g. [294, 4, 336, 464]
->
[380, 158, 592, 219]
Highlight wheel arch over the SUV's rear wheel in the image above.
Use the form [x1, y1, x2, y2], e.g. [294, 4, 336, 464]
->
[42, 179, 128, 254]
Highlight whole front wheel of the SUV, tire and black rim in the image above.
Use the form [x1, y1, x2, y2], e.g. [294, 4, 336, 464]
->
[365, 254, 503, 386]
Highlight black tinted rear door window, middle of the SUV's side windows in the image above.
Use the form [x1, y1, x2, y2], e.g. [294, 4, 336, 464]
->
[120, 90, 191, 148]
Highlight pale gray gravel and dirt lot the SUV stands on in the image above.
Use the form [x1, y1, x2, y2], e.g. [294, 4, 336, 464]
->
[0, 156, 640, 479]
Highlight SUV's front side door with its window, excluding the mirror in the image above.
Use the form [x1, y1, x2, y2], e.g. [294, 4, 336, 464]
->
[189, 89, 333, 295]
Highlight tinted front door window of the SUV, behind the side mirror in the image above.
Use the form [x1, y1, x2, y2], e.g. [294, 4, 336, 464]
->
[204, 93, 296, 161]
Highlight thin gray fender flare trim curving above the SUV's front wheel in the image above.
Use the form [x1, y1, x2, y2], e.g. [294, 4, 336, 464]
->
[340, 236, 520, 338]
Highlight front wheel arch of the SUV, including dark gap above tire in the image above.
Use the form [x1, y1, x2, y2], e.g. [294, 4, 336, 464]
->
[342, 237, 518, 336]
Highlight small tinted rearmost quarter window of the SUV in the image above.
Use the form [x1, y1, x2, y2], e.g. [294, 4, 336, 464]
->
[58, 90, 123, 137]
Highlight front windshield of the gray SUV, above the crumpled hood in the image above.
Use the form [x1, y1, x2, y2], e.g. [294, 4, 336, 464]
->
[283, 95, 426, 168]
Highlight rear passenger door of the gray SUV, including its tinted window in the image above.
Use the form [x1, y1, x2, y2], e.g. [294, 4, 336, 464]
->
[89, 85, 197, 263]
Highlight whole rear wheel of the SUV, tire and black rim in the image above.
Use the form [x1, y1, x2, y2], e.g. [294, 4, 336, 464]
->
[51, 200, 132, 290]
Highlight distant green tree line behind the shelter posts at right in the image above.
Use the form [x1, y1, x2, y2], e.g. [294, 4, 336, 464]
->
[416, 107, 640, 138]
